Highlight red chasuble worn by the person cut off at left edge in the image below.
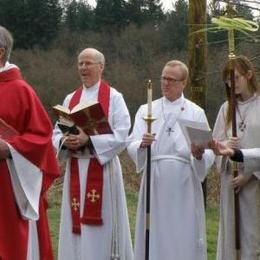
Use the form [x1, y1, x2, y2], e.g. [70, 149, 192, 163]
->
[0, 68, 59, 260]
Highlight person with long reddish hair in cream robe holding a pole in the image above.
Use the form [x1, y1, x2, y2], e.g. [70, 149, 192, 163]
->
[213, 56, 260, 260]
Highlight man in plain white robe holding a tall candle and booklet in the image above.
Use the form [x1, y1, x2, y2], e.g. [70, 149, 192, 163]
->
[128, 60, 214, 260]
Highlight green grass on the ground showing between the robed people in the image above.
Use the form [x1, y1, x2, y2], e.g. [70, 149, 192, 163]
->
[48, 186, 218, 260]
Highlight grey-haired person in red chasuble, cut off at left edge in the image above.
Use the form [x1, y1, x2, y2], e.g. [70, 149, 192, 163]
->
[0, 26, 59, 260]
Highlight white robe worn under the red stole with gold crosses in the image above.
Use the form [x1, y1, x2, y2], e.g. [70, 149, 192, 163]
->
[53, 82, 133, 260]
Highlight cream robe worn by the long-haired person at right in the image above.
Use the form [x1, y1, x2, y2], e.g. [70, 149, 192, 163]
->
[213, 97, 260, 260]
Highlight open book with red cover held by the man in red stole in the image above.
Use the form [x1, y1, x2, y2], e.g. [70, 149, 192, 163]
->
[53, 102, 113, 135]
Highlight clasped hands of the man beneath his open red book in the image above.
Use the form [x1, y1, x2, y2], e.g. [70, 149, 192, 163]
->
[63, 127, 89, 151]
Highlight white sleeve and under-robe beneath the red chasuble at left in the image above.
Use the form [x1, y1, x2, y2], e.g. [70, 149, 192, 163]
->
[6, 144, 42, 260]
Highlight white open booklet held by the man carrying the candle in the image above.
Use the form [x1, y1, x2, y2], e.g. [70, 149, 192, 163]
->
[178, 119, 212, 148]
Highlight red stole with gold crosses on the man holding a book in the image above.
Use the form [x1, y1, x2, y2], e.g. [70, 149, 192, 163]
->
[69, 81, 110, 234]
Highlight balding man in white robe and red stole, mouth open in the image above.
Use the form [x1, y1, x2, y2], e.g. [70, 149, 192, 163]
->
[53, 48, 133, 260]
